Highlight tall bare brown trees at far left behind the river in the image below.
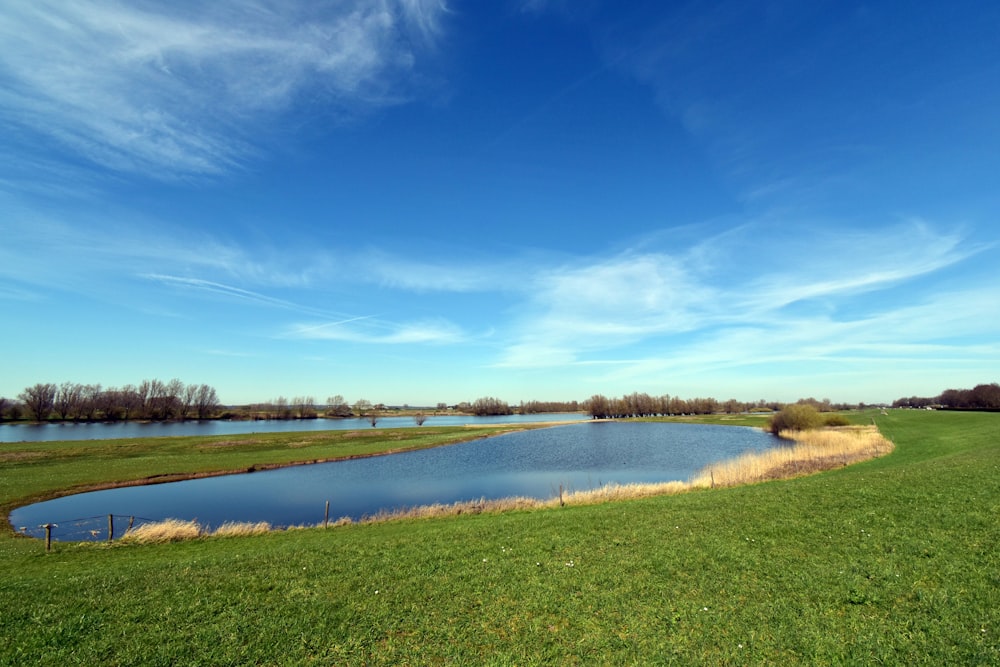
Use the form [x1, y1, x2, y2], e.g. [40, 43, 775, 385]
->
[0, 378, 220, 422]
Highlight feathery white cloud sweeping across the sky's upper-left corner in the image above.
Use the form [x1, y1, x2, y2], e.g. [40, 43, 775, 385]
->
[0, 0, 445, 178]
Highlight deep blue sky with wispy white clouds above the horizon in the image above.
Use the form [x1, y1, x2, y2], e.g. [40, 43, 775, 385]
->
[0, 0, 1000, 405]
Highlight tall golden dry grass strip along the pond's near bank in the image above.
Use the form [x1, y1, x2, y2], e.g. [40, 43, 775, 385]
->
[113, 426, 894, 544]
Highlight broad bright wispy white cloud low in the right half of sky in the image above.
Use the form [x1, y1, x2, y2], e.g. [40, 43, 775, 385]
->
[500, 221, 996, 373]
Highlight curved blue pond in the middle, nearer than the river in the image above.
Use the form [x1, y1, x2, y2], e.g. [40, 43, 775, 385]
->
[10, 422, 782, 540]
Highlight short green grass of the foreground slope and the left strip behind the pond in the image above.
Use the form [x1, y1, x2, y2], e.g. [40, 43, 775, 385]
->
[0, 411, 1000, 665]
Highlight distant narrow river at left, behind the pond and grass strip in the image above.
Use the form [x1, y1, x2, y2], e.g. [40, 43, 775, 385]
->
[0, 412, 588, 442]
